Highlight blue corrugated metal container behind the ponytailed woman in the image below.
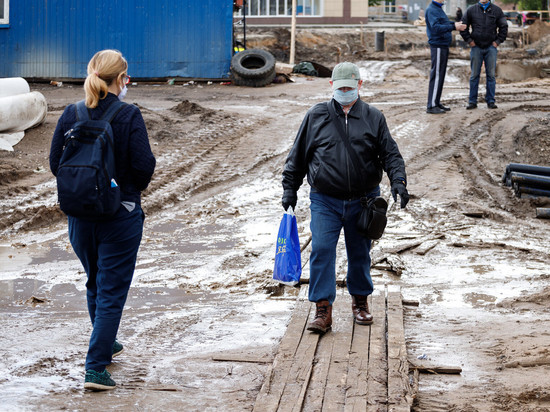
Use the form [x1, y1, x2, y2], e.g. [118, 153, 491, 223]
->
[0, 0, 233, 79]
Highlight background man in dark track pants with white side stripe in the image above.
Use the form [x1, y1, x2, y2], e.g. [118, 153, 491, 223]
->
[425, 0, 466, 114]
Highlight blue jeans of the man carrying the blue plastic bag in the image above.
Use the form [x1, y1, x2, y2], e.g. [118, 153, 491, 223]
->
[309, 188, 380, 304]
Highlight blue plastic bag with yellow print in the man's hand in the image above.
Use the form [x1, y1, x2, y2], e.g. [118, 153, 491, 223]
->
[273, 207, 302, 286]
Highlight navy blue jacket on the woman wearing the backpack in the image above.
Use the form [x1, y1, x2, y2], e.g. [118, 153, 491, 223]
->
[50, 93, 156, 204]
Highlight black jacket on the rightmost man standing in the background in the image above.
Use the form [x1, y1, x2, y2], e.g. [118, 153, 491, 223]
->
[460, 3, 508, 49]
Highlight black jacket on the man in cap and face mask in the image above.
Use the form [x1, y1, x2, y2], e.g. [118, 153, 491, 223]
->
[283, 99, 406, 199]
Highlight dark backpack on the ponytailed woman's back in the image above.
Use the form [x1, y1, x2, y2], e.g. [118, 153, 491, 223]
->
[57, 100, 126, 218]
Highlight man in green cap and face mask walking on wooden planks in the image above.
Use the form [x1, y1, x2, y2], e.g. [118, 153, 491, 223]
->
[283, 62, 409, 333]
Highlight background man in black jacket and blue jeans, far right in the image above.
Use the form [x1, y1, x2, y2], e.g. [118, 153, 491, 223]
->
[460, 0, 508, 110]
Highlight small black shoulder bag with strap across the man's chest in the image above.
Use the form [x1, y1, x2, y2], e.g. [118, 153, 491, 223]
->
[327, 102, 388, 240]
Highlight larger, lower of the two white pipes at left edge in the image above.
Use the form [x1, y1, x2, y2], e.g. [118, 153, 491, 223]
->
[0, 92, 48, 133]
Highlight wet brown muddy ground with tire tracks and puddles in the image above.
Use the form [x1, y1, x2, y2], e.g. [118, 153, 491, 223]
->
[0, 29, 550, 412]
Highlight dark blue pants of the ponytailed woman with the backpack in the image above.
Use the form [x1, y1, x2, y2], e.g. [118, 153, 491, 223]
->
[69, 205, 144, 372]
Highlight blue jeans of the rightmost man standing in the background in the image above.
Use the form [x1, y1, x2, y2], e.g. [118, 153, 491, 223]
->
[468, 46, 498, 104]
